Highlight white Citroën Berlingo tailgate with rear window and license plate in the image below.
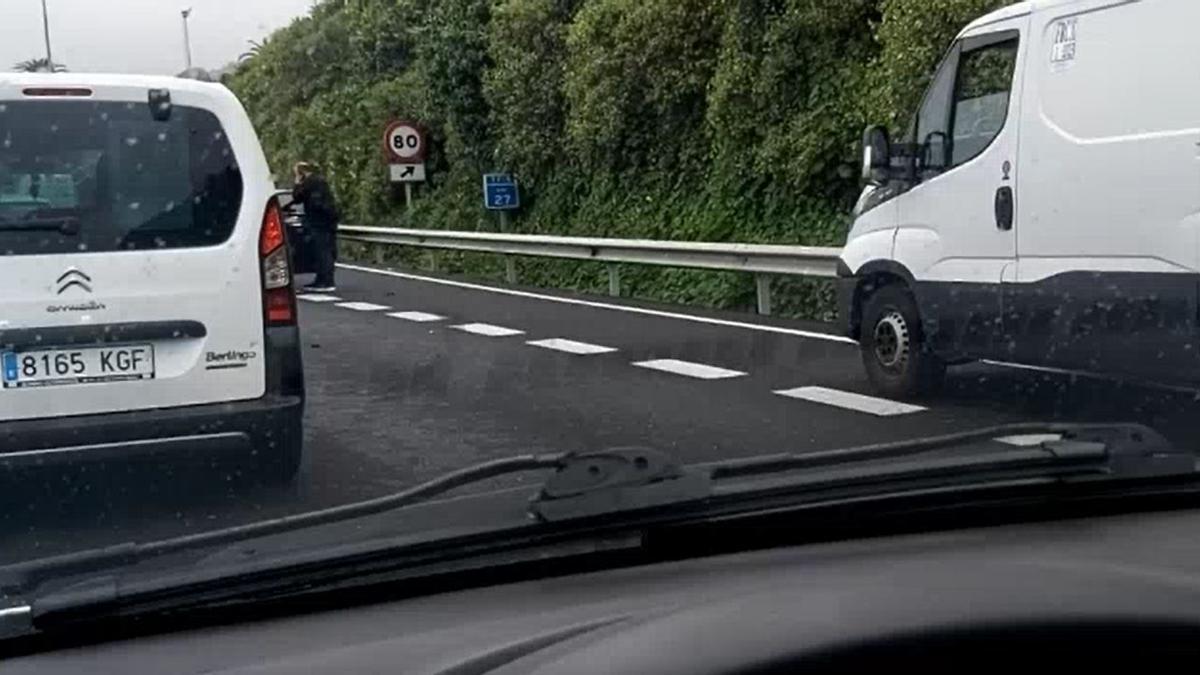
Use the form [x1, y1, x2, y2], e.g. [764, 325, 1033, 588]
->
[0, 82, 268, 420]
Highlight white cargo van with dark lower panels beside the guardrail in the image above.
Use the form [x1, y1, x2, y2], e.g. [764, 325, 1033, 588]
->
[839, 0, 1200, 396]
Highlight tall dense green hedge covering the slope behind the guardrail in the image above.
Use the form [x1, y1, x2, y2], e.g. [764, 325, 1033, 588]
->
[229, 0, 1008, 318]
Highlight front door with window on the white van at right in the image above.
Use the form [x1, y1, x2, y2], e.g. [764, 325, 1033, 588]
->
[894, 14, 1028, 358]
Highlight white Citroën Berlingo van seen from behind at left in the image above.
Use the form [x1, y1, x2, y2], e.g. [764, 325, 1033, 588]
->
[0, 74, 304, 479]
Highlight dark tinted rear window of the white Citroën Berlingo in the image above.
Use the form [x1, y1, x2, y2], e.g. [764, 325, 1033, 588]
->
[0, 101, 242, 255]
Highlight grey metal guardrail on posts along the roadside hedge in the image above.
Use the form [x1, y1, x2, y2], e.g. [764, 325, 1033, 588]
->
[338, 225, 841, 315]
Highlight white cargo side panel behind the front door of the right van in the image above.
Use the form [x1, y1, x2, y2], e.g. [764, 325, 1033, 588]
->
[1004, 0, 1200, 380]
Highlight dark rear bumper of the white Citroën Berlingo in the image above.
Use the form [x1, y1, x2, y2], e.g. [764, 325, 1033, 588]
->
[0, 395, 304, 468]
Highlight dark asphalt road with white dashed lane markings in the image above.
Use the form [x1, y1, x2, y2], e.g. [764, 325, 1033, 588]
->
[0, 263, 1200, 563]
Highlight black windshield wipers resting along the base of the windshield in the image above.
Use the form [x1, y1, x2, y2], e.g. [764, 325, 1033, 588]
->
[0, 423, 1196, 593]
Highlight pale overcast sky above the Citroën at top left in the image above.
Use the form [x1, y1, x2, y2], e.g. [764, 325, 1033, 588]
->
[0, 0, 313, 74]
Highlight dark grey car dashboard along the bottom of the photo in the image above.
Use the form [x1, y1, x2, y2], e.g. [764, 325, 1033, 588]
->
[11, 510, 1200, 675]
